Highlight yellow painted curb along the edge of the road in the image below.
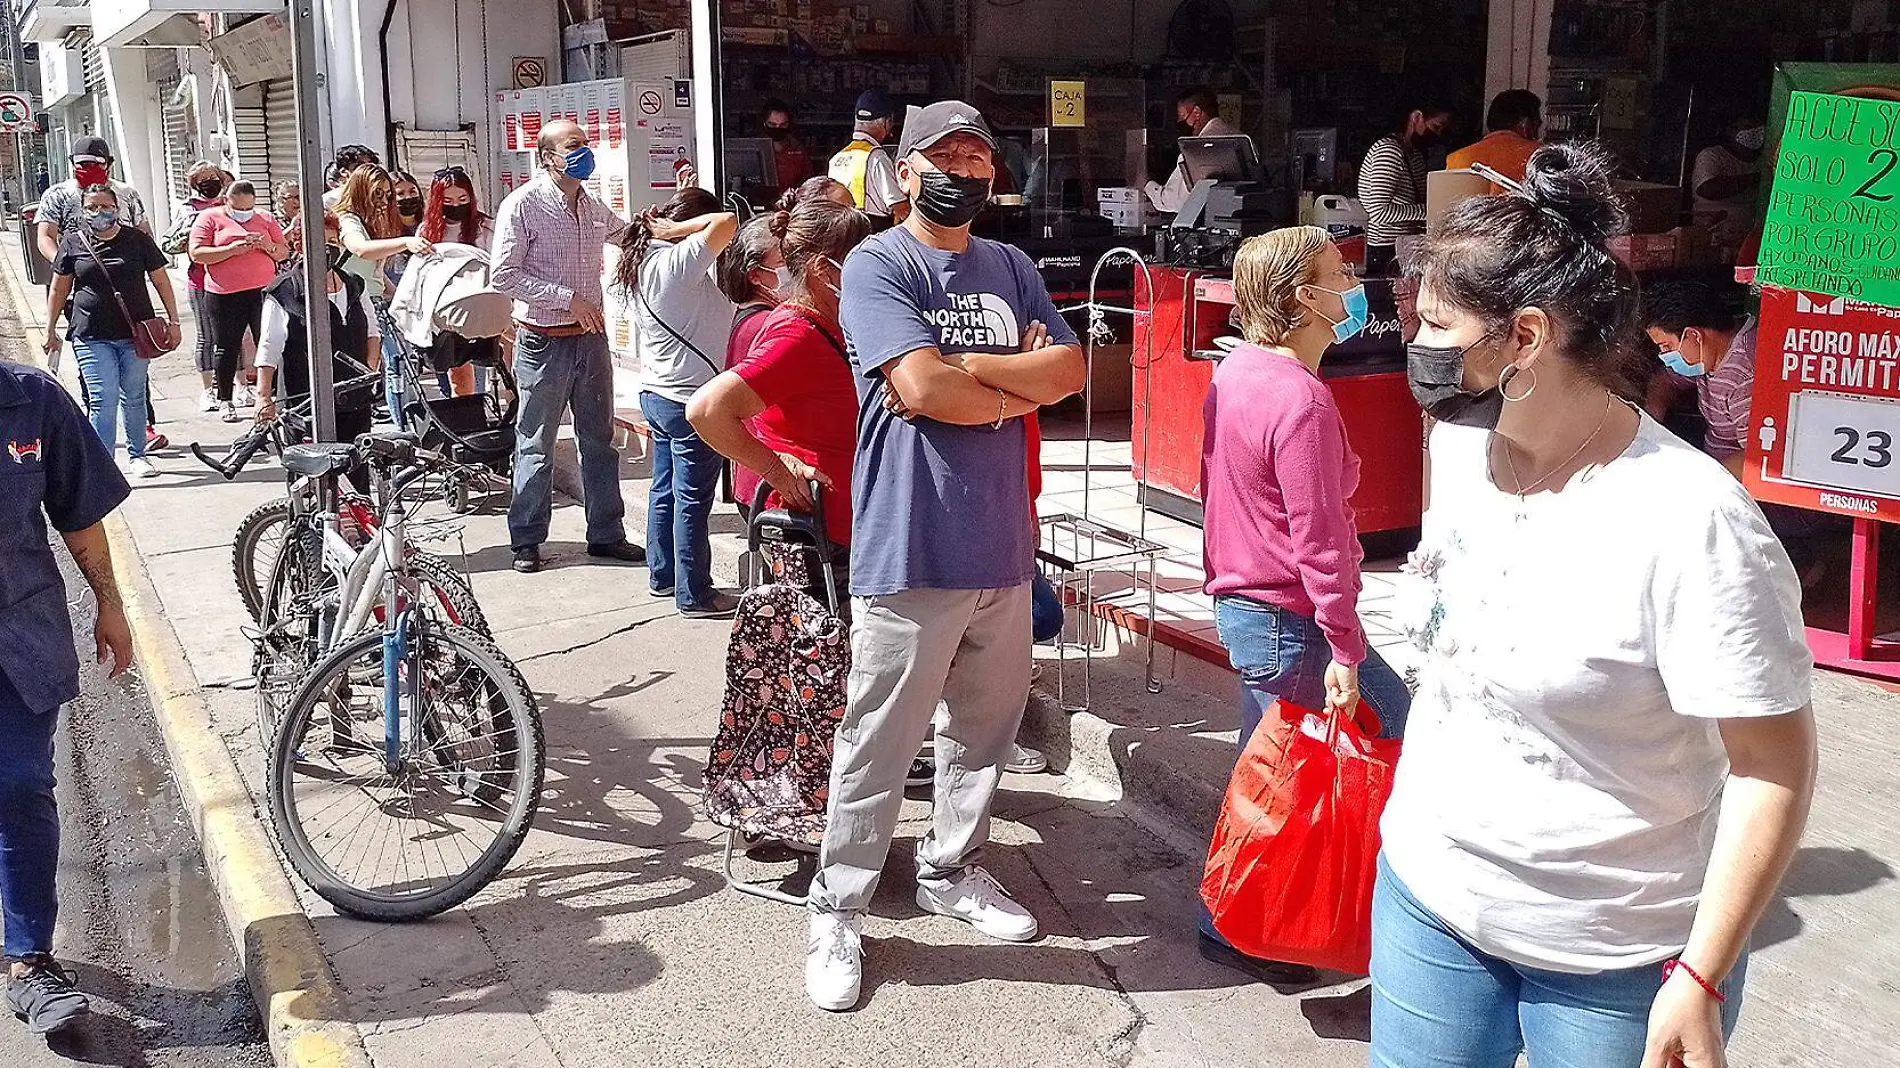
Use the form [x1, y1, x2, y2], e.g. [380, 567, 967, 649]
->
[105, 513, 371, 1068]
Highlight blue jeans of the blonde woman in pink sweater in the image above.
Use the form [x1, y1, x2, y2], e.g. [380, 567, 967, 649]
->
[1199, 595, 1412, 944]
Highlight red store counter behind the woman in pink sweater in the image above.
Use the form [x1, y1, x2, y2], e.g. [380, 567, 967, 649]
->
[1132, 268, 1425, 534]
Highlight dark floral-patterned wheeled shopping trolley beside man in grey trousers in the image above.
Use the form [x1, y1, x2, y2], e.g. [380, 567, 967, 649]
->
[705, 485, 851, 905]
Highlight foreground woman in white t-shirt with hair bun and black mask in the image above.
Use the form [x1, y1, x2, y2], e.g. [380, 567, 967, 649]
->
[1372, 144, 1815, 1068]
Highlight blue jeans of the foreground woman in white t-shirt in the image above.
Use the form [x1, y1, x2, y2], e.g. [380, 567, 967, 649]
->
[1372, 857, 1748, 1068]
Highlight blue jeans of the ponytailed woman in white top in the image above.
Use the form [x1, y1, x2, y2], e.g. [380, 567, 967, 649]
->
[640, 393, 726, 608]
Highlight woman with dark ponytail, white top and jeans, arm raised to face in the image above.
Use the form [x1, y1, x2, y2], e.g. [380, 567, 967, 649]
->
[614, 186, 739, 620]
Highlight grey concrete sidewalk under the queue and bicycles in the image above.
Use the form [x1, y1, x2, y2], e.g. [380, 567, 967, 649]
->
[11, 226, 1900, 1068]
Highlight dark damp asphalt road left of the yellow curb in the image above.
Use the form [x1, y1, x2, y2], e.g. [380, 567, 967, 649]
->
[0, 324, 270, 1068]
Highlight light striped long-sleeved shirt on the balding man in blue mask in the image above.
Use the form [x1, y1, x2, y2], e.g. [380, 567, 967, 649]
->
[488, 175, 627, 327]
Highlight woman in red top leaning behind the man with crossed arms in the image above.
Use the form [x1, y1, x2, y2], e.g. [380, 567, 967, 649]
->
[686, 200, 870, 545]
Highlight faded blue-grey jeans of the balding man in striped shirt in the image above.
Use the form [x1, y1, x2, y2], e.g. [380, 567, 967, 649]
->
[507, 329, 627, 549]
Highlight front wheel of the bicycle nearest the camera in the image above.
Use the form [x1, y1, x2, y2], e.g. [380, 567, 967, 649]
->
[270, 614, 543, 920]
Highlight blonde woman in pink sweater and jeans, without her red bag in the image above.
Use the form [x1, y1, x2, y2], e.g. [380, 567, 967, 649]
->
[1201, 226, 1412, 982]
